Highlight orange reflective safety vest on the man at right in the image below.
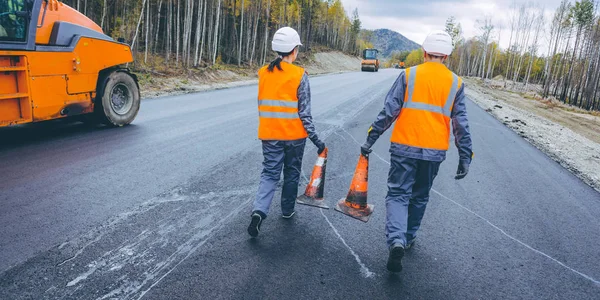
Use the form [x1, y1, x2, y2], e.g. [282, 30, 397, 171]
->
[391, 62, 462, 151]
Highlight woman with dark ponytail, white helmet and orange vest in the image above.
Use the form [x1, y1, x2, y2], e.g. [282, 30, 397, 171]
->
[248, 27, 325, 237]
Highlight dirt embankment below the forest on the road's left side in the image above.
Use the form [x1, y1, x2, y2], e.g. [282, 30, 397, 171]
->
[138, 52, 360, 98]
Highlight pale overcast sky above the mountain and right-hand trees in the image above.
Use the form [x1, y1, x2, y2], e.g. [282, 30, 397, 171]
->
[342, 0, 561, 52]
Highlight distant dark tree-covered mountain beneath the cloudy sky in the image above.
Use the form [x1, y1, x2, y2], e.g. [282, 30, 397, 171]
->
[361, 29, 421, 58]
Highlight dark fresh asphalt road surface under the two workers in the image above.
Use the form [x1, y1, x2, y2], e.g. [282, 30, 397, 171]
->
[0, 70, 600, 299]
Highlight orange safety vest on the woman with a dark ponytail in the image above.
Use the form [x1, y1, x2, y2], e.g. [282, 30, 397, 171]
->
[258, 62, 308, 141]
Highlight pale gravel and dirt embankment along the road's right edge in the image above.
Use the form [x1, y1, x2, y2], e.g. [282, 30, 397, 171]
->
[466, 79, 600, 191]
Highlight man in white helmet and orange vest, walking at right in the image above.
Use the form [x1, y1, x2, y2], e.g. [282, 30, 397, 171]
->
[361, 31, 473, 272]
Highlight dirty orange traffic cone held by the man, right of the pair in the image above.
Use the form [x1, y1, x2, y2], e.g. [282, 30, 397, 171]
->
[335, 154, 374, 223]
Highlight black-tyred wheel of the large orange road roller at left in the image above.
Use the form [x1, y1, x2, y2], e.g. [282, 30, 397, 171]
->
[95, 71, 140, 126]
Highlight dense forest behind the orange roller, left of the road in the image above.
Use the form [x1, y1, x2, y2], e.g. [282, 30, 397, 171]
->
[63, 0, 361, 69]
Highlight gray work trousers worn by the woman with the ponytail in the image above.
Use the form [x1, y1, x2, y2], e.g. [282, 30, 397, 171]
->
[253, 139, 306, 218]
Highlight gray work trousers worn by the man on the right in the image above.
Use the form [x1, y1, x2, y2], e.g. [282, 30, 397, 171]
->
[385, 154, 441, 247]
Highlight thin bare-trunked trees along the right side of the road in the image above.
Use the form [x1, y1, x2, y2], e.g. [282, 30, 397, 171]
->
[446, 0, 600, 111]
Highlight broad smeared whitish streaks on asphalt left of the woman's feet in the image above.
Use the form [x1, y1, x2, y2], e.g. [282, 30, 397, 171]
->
[47, 187, 255, 299]
